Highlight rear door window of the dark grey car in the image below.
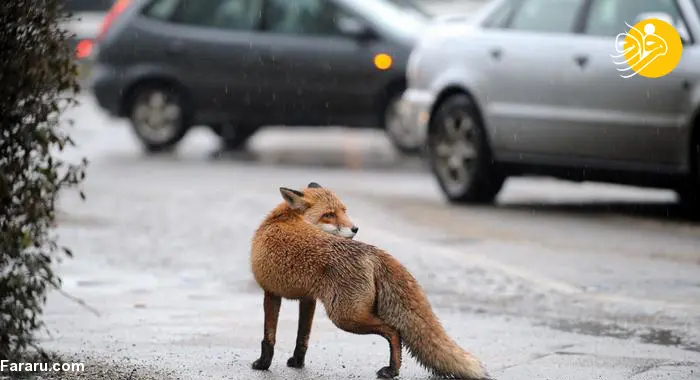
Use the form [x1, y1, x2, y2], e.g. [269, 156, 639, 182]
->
[174, 0, 262, 30]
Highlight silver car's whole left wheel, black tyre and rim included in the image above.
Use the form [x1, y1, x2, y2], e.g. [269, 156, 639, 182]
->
[427, 94, 505, 203]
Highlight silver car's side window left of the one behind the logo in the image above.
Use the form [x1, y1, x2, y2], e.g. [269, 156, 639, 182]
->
[508, 0, 583, 33]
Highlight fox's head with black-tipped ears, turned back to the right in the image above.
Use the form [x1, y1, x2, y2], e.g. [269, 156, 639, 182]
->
[280, 182, 359, 239]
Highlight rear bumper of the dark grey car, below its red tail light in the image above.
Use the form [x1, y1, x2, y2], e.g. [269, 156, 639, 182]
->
[87, 62, 124, 116]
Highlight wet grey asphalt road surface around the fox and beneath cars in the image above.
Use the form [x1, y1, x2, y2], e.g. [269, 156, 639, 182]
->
[31, 92, 700, 380]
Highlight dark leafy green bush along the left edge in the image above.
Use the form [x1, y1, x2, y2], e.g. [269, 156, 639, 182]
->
[0, 0, 86, 361]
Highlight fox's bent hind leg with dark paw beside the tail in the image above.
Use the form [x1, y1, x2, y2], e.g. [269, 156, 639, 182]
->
[331, 313, 401, 379]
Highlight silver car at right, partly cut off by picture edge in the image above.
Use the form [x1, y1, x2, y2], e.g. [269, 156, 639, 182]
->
[400, 0, 700, 211]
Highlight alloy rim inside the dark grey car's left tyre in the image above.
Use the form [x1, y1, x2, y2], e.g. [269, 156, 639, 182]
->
[133, 91, 182, 144]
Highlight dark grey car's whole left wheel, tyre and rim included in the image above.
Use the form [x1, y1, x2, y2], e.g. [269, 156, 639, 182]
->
[128, 84, 190, 152]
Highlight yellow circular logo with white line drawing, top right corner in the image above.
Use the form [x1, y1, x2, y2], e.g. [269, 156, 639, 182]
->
[620, 19, 683, 78]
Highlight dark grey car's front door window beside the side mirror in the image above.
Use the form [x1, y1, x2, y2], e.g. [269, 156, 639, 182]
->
[264, 0, 345, 35]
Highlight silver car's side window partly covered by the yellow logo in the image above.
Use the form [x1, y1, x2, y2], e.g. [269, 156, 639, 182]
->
[584, 0, 682, 37]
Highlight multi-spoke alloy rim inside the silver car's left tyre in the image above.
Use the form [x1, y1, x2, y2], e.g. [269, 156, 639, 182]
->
[433, 111, 478, 194]
